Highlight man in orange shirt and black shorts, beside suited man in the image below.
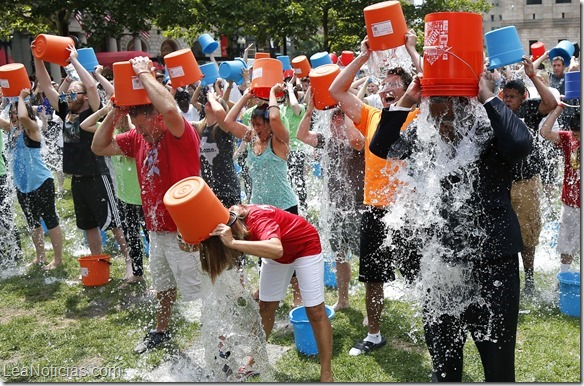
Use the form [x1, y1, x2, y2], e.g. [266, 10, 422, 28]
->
[329, 37, 419, 356]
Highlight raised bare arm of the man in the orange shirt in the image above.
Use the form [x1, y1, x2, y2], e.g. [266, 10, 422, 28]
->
[329, 37, 371, 124]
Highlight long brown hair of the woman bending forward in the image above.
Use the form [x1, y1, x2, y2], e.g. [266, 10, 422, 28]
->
[199, 212, 249, 283]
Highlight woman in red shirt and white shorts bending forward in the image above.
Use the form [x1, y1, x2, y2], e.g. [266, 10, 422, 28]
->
[192, 205, 333, 382]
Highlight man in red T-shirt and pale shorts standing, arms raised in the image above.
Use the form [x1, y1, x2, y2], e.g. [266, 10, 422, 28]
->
[91, 56, 201, 354]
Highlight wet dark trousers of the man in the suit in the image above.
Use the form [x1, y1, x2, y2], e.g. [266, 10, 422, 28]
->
[423, 255, 519, 382]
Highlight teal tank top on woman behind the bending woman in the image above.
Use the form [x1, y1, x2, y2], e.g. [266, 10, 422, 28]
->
[247, 138, 298, 209]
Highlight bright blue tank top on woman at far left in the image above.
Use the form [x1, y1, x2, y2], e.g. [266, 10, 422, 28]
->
[8, 128, 53, 193]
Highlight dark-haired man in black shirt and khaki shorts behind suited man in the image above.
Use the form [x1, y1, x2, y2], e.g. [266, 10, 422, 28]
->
[502, 57, 558, 296]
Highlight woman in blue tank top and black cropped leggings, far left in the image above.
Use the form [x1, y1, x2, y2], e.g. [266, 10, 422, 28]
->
[0, 89, 63, 270]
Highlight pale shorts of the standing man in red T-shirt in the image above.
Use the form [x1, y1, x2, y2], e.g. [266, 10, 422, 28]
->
[150, 232, 201, 301]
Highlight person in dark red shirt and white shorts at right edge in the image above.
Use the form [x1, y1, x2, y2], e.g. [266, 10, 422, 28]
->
[540, 103, 582, 272]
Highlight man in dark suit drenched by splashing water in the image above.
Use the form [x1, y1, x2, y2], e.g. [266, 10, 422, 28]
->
[369, 71, 532, 382]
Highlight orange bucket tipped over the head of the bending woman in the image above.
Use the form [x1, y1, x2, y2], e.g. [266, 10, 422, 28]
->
[164, 176, 230, 244]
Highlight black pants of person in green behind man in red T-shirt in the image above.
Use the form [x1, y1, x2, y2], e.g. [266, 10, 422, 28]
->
[118, 199, 148, 276]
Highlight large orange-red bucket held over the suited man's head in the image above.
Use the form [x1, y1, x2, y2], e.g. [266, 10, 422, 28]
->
[422, 12, 484, 97]
